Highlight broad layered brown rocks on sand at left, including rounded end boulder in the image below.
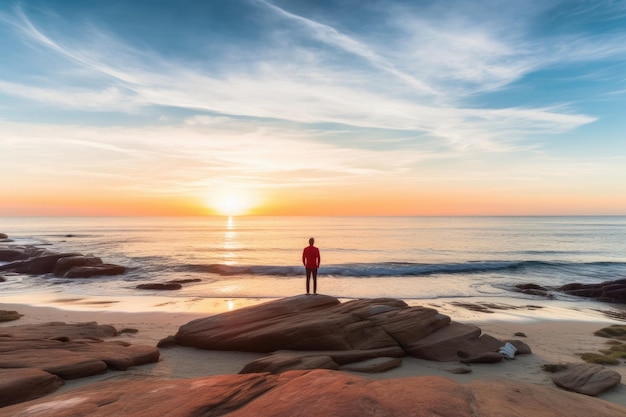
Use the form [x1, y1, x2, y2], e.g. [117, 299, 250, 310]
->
[0, 322, 159, 405]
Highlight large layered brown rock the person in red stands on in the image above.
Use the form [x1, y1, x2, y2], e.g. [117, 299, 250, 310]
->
[175, 295, 529, 372]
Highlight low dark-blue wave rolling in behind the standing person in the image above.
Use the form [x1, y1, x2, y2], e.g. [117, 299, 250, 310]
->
[171, 261, 626, 277]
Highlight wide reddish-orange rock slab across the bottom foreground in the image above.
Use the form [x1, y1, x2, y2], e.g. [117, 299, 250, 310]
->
[0, 370, 626, 417]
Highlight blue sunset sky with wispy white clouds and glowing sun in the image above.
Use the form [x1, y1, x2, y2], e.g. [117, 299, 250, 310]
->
[0, 0, 626, 216]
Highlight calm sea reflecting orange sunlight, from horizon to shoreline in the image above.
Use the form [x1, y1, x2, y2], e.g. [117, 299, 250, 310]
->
[0, 217, 626, 300]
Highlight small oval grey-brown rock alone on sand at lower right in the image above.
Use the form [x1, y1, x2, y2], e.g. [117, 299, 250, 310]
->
[552, 363, 622, 396]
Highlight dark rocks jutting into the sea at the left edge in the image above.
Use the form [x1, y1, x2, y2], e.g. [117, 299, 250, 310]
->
[0, 246, 126, 278]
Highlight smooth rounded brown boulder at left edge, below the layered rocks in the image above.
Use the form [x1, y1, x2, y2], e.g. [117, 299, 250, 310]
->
[0, 368, 63, 407]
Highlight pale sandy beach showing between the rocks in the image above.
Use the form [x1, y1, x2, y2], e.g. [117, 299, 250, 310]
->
[0, 297, 626, 405]
